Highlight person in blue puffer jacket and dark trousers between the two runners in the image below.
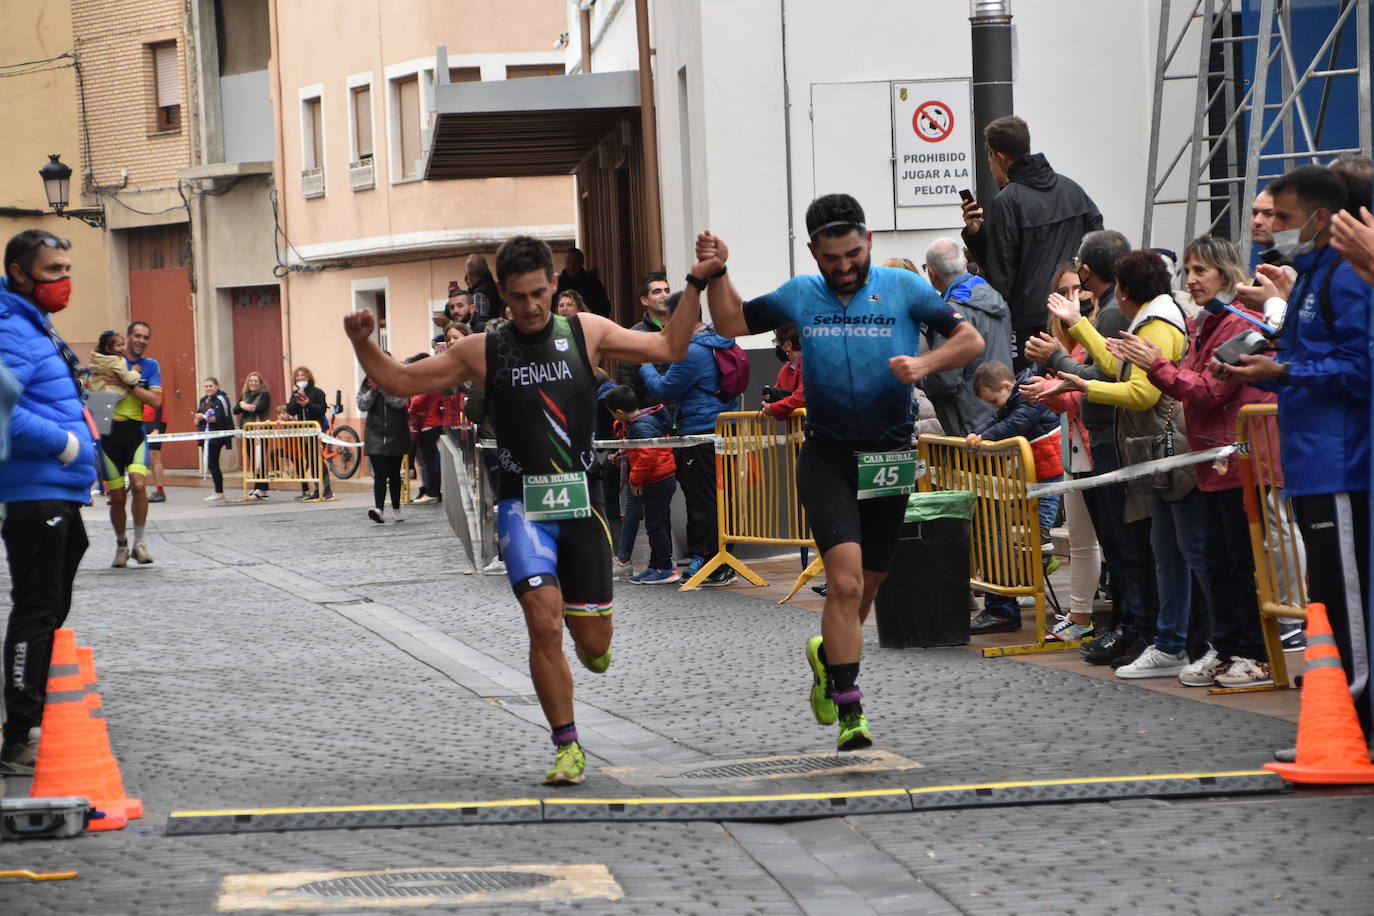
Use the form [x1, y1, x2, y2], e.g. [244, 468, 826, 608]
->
[639, 293, 739, 585]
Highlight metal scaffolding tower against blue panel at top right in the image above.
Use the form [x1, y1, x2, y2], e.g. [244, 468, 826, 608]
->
[1142, 0, 1371, 260]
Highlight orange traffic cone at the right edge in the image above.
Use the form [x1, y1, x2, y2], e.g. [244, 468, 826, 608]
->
[1264, 604, 1374, 786]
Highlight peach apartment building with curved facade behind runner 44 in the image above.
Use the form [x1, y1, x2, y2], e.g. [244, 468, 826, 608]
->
[271, 0, 577, 403]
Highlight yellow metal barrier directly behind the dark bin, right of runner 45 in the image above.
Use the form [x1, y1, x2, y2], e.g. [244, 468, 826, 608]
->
[916, 434, 1079, 658]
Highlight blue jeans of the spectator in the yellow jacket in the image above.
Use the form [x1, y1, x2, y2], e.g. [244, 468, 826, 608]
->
[1150, 490, 1216, 655]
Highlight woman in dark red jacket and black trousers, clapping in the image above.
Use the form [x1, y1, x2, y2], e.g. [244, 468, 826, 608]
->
[1106, 236, 1274, 687]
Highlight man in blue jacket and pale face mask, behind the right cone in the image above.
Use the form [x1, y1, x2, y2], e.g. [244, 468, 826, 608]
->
[1217, 165, 1374, 740]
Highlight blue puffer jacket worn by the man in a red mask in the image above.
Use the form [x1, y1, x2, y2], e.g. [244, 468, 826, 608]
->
[0, 277, 95, 504]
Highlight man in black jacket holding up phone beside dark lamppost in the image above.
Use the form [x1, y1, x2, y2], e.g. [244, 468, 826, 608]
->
[963, 117, 1102, 371]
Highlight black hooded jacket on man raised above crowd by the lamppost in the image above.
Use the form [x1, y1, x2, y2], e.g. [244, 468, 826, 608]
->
[963, 152, 1102, 330]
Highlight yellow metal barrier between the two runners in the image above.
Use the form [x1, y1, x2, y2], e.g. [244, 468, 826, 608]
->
[680, 411, 820, 602]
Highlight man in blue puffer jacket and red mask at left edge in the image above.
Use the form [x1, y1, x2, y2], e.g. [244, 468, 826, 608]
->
[0, 229, 95, 776]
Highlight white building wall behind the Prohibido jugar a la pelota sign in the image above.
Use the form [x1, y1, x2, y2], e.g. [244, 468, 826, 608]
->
[596, 0, 1197, 325]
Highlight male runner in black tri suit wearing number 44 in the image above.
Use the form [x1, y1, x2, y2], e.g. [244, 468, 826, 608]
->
[344, 236, 720, 786]
